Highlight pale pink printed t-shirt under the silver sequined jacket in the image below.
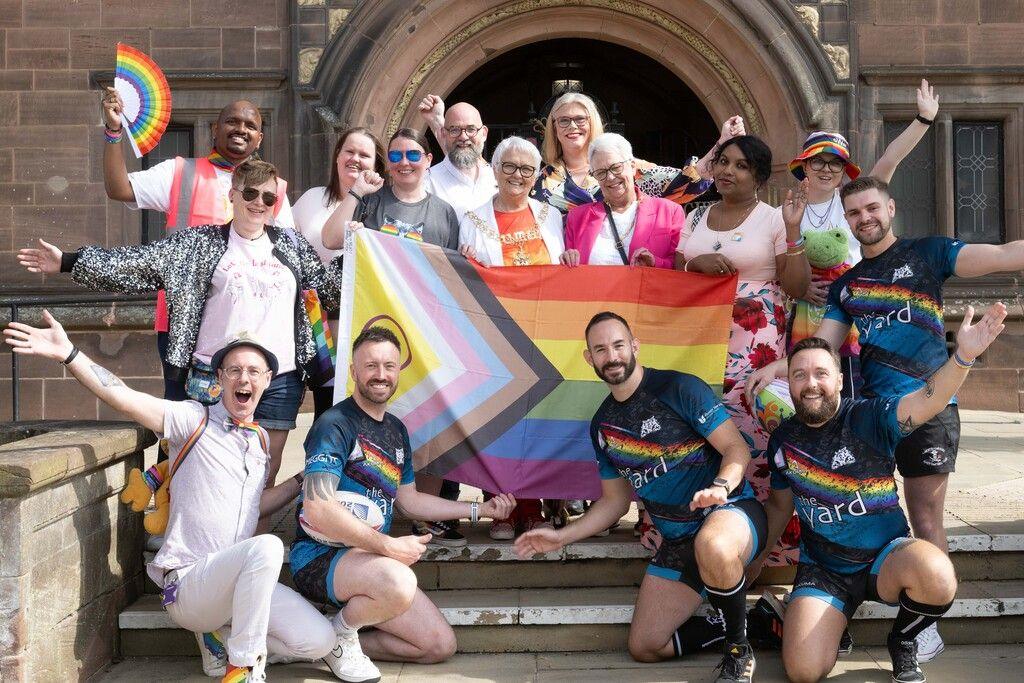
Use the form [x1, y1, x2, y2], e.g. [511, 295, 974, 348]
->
[195, 229, 295, 373]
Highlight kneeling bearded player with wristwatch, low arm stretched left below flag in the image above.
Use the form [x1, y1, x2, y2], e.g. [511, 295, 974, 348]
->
[515, 311, 767, 681]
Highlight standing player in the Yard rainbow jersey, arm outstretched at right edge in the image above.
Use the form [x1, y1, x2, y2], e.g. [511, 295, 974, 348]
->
[745, 176, 1024, 661]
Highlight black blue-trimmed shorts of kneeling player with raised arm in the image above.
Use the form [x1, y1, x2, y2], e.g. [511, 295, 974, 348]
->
[791, 537, 913, 621]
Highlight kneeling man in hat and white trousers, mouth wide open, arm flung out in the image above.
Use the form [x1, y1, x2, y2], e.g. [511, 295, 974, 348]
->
[4, 311, 338, 683]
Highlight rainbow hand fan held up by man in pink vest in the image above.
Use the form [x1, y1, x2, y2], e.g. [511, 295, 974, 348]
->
[114, 43, 171, 157]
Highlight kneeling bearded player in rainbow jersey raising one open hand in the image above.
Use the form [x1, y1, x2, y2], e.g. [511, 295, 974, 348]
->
[767, 303, 1007, 683]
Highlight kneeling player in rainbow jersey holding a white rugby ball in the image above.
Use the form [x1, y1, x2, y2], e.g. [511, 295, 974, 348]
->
[291, 327, 515, 682]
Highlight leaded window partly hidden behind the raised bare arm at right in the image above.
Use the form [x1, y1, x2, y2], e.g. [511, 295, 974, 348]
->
[880, 121, 940, 238]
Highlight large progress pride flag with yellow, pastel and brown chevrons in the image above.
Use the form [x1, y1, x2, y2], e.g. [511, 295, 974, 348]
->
[335, 230, 736, 500]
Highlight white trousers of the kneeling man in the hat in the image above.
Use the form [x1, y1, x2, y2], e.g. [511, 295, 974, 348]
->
[167, 535, 338, 667]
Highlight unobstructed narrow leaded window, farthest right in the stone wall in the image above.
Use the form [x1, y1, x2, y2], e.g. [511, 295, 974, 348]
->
[953, 121, 1004, 244]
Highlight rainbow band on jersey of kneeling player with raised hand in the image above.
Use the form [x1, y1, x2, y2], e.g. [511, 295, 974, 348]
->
[783, 444, 899, 513]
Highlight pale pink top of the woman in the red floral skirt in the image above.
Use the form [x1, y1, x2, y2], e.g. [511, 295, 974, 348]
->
[676, 202, 786, 282]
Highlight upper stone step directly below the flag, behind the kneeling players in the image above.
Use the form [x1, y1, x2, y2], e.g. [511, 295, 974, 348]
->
[145, 528, 1024, 593]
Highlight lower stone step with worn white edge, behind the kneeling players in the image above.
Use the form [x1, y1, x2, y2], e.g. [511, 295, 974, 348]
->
[119, 581, 1024, 656]
